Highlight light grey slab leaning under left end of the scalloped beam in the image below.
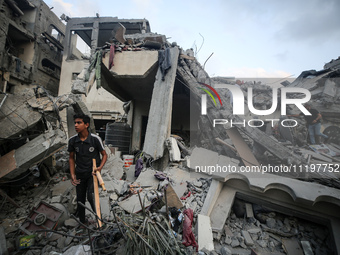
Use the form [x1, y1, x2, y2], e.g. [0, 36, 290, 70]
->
[210, 186, 236, 232]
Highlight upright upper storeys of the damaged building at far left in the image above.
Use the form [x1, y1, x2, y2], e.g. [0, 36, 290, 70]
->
[0, 0, 65, 96]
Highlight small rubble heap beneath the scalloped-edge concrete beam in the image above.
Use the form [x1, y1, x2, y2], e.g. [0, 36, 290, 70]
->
[214, 200, 334, 255]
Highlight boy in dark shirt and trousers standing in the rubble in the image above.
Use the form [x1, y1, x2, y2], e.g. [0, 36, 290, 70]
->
[68, 114, 107, 224]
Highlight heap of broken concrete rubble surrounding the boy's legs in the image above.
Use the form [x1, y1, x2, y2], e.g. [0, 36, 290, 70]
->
[0, 144, 216, 255]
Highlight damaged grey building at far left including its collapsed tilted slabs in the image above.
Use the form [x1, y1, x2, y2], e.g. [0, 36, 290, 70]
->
[0, 0, 68, 182]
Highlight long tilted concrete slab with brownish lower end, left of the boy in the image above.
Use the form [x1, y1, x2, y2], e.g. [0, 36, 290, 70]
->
[0, 129, 67, 179]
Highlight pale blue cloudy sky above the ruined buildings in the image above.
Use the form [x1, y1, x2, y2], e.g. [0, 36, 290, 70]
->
[45, 0, 340, 78]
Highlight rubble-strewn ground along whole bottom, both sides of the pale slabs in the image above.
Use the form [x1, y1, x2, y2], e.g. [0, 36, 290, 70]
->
[0, 142, 335, 255]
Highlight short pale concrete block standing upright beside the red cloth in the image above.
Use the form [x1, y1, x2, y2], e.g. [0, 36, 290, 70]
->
[197, 214, 214, 251]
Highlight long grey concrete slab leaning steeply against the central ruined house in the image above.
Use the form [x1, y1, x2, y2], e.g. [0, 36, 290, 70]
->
[143, 47, 179, 159]
